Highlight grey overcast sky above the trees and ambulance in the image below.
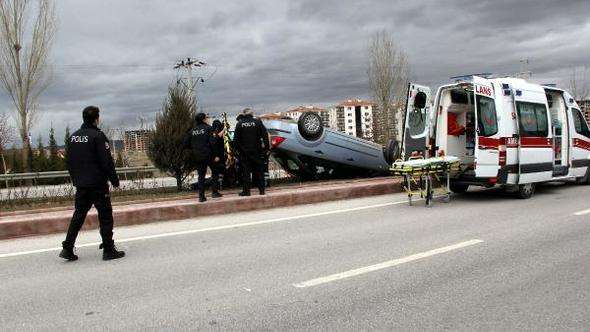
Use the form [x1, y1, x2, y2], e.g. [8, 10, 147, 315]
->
[0, 0, 590, 141]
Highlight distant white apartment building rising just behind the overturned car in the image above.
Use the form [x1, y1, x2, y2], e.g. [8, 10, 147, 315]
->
[329, 99, 375, 140]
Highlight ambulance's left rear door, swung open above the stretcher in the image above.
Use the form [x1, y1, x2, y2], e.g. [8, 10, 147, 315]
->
[402, 83, 431, 160]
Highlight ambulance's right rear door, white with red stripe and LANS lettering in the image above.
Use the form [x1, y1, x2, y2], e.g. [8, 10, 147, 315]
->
[473, 76, 501, 178]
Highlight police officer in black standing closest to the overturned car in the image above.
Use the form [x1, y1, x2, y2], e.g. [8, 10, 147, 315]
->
[234, 108, 270, 196]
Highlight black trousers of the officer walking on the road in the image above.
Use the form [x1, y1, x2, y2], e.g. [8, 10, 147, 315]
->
[63, 186, 113, 248]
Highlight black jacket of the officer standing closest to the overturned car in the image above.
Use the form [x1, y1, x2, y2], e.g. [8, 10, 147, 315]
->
[234, 115, 270, 155]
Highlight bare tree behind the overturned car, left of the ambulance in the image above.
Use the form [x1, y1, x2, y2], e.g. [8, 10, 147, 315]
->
[367, 30, 410, 143]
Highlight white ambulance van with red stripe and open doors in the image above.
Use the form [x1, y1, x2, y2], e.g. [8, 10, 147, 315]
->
[402, 76, 590, 198]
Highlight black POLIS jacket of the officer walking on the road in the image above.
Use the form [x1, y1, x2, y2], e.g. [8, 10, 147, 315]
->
[66, 124, 119, 188]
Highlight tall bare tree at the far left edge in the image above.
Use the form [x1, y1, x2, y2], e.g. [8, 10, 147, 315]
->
[0, 0, 56, 171]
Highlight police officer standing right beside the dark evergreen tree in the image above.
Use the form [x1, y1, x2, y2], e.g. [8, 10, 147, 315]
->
[185, 113, 221, 202]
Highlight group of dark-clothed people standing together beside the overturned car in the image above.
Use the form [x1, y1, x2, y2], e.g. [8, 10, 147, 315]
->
[184, 108, 270, 202]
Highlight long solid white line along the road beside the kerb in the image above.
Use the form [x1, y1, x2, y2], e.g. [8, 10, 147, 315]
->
[0, 197, 416, 258]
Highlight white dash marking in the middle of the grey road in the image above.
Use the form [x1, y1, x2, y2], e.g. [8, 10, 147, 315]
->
[293, 239, 483, 288]
